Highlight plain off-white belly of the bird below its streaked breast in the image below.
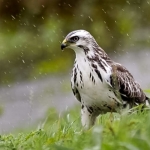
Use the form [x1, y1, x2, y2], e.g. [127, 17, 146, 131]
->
[78, 81, 120, 112]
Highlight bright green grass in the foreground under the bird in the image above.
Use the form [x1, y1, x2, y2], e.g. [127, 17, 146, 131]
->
[0, 108, 150, 150]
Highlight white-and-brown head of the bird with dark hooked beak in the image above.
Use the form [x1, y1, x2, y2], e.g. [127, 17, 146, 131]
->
[61, 30, 93, 51]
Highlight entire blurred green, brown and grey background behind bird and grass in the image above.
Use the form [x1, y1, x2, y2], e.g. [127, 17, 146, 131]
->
[0, 0, 150, 133]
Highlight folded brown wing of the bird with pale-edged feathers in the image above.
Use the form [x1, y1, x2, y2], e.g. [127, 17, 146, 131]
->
[111, 63, 146, 104]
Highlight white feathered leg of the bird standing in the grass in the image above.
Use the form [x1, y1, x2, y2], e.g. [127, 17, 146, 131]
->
[81, 105, 97, 129]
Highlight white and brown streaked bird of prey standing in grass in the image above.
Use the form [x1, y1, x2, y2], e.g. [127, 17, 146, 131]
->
[61, 29, 150, 129]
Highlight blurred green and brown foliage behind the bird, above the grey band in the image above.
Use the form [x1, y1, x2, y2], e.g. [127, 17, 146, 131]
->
[0, 0, 150, 84]
